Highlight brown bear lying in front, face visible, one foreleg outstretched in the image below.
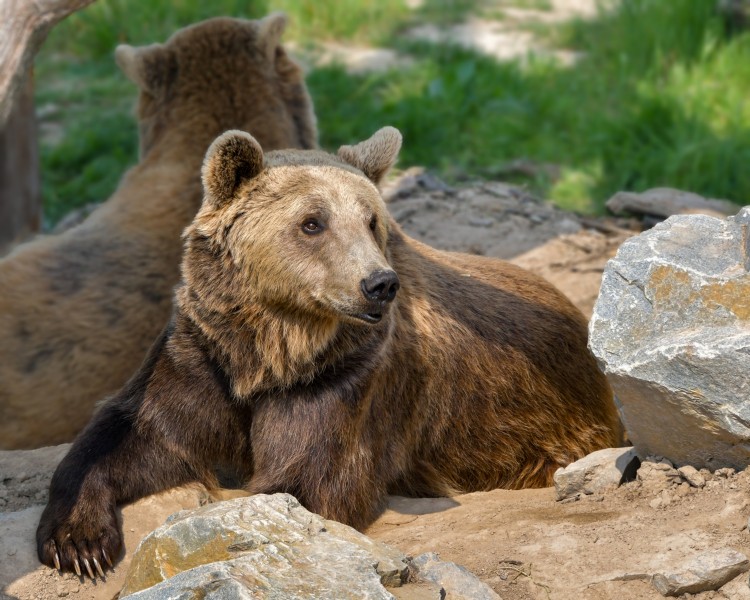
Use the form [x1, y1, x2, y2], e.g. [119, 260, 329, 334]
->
[37, 128, 618, 576]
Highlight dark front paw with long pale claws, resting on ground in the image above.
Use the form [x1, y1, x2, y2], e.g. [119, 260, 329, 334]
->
[36, 505, 122, 579]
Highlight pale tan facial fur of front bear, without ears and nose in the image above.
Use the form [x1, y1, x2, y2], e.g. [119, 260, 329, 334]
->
[210, 166, 391, 319]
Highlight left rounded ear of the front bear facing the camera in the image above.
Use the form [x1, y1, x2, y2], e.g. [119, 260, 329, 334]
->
[201, 130, 263, 207]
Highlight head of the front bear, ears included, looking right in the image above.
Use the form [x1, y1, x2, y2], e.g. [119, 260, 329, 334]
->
[183, 127, 401, 326]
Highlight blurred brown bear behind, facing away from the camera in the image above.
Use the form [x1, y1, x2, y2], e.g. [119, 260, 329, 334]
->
[0, 14, 317, 449]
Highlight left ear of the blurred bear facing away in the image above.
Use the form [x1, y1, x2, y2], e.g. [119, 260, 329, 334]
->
[115, 44, 177, 96]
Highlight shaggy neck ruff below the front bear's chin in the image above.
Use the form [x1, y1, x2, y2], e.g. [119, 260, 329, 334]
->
[177, 285, 393, 400]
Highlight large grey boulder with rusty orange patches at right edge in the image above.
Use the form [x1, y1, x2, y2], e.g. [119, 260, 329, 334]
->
[589, 209, 750, 470]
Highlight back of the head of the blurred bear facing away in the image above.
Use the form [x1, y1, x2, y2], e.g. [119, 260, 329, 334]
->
[115, 13, 317, 157]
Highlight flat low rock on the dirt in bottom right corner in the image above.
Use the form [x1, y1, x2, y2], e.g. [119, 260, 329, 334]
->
[651, 548, 750, 596]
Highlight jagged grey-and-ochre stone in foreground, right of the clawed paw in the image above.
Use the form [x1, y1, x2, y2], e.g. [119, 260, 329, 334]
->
[120, 494, 408, 600]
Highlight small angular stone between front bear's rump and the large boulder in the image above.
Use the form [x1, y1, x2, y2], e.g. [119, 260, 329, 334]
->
[554, 448, 641, 500]
